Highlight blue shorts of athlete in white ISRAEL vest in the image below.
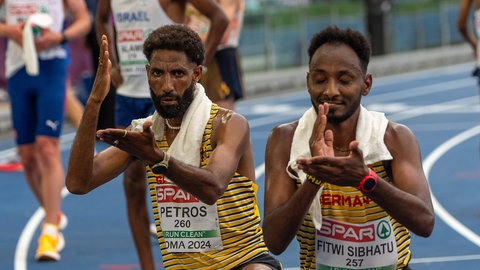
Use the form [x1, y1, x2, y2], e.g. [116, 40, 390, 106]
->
[115, 95, 155, 128]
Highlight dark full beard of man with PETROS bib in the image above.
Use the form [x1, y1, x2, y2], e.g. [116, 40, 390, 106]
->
[150, 83, 195, 119]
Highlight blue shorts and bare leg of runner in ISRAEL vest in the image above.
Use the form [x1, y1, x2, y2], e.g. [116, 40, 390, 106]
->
[115, 96, 155, 270]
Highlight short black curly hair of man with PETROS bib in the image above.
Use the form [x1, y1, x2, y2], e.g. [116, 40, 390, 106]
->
[143, 24, 205, 65]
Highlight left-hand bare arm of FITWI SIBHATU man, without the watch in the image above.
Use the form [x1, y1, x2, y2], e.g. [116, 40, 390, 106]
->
[263, 122, 319, 255]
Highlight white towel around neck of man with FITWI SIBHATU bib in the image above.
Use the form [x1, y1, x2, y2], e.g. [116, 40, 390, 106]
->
[286, 106, 392, 230]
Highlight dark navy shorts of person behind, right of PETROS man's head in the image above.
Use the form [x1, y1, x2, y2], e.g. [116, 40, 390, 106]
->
[215, 48, 244, 100]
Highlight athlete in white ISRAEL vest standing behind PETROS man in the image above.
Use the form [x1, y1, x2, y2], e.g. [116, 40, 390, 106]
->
[95, 0, 228, 270]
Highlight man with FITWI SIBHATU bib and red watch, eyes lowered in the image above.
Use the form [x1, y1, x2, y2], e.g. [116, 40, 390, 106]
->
[263, 26, 435, 270]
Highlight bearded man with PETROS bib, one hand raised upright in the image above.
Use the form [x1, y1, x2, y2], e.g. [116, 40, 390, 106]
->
[66, 25, 281, 269]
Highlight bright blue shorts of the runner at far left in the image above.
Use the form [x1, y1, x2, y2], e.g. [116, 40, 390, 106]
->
[7, 58, 68, 145]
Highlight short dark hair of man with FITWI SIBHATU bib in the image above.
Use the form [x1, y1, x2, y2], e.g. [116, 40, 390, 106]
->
[308, 26, 371, 72]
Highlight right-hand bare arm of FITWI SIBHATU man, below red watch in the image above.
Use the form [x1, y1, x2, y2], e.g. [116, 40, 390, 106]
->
[368, 122, 435, 237]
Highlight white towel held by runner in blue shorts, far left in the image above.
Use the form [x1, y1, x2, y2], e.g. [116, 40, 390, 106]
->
[22, 13, 53, 76]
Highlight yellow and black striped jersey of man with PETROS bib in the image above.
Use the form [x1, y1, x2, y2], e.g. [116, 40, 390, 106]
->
[147, 104, 268, 269]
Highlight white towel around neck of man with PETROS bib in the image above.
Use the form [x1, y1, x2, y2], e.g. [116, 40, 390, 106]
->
[132, 83, 212, 167]
